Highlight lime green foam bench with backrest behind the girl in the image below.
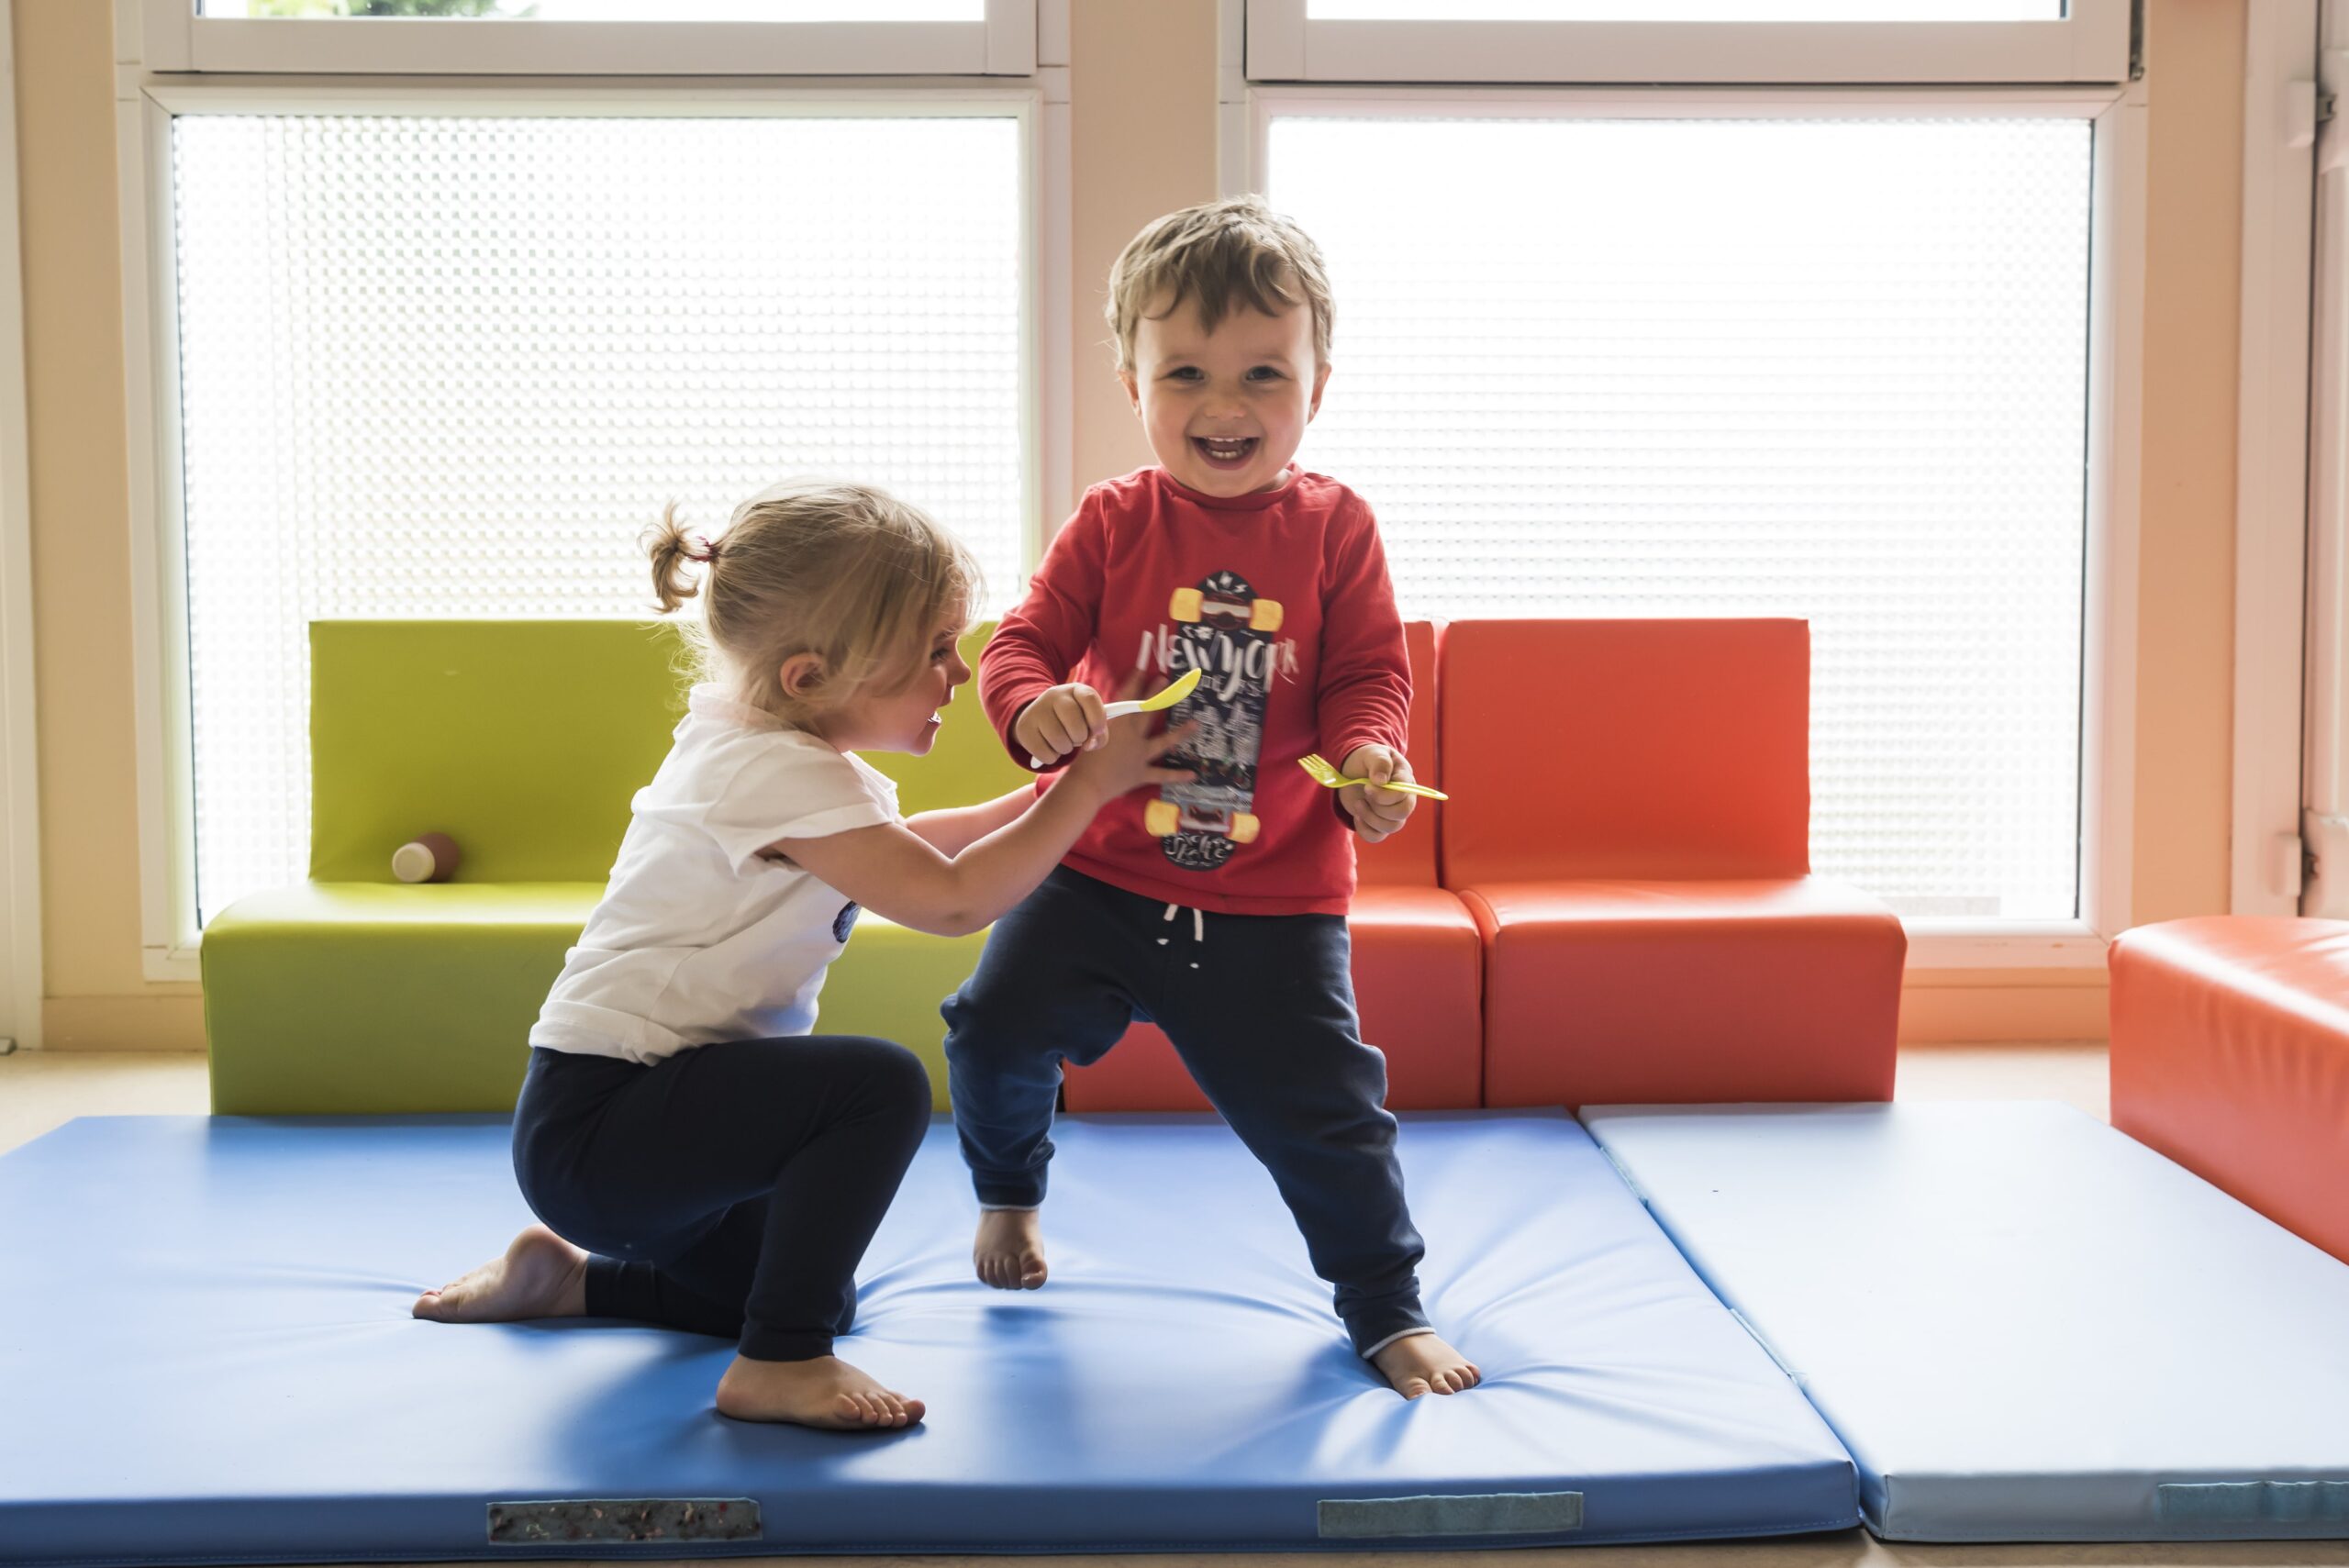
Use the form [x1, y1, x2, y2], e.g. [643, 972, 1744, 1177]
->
[202, 619, 1029, 1115]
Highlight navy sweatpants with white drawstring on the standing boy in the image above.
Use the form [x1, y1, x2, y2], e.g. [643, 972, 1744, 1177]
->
[942, 866, 1428, 1357]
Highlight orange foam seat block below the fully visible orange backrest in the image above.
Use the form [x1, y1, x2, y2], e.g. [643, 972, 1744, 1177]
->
[1464, 878, 1908, 1106]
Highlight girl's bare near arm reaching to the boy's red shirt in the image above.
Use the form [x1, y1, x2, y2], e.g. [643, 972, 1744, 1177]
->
[768, 714, 1193, 937]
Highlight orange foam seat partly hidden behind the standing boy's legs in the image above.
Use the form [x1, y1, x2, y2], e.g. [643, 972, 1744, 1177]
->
[1064, 887, 1485, 1110]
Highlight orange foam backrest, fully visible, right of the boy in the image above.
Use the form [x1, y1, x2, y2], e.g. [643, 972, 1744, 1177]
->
[1438, 619, 1811, 887]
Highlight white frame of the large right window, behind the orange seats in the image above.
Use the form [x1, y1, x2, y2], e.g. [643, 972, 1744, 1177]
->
[1249, 85, 2144, 972]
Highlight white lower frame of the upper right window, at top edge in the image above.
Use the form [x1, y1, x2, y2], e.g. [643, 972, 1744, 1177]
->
[1245, 0, 2132, 84]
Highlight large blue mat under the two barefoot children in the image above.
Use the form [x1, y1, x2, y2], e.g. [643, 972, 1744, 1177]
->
[0, 1113, 1858, 1563]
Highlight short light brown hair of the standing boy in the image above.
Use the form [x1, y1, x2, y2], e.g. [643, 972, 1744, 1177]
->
[1104, 195, 1337, 375]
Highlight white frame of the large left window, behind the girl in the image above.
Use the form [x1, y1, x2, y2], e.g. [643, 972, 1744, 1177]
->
[115, 67, 1075, 981]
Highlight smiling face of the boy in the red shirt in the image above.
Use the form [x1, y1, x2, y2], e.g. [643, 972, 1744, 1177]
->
[1119, 287, 1330, 495]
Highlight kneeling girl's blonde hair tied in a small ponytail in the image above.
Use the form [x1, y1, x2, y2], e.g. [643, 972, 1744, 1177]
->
[641, 479, 980, 726]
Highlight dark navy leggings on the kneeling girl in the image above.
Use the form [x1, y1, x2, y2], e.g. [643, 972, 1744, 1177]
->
[515, 1035, 930, 1362]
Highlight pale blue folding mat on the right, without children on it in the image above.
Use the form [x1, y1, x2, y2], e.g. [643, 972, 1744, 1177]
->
[1583, 1103, 2349, 1540]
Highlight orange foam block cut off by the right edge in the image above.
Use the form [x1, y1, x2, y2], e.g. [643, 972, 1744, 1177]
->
[2110, 916, 2349, 1261]
